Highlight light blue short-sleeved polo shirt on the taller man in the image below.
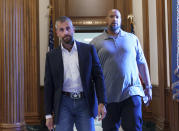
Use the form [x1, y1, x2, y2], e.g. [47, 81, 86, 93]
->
[90, 30, 146, 103]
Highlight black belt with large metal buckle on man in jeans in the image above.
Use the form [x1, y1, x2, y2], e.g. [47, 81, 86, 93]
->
[62, 91, 84, 99]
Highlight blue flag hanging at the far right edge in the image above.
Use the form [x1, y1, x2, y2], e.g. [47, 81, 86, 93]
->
[171, 0, 179, 102]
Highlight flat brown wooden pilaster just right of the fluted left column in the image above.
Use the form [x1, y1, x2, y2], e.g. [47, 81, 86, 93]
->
[24, 0, 40, 124]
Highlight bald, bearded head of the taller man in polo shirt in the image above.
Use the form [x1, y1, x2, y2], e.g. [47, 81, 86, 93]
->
[106, 9, 121, 33]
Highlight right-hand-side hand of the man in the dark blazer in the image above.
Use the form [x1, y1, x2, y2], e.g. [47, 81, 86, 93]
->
[98, 103, 107, 121]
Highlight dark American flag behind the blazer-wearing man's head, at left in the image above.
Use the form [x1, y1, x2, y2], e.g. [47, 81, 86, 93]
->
[48, 16, 54, 51]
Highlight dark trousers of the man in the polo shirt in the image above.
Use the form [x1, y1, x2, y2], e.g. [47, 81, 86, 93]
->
[102, 96, 143, 131]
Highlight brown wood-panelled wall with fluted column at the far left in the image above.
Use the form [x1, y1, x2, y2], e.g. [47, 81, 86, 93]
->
[0, 0, 40, 129]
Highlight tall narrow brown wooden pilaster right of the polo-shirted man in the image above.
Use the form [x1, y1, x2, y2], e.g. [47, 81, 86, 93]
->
[153, 0, 168, 130]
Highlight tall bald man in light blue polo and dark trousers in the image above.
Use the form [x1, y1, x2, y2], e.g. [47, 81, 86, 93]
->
[91, 9, 152, 131]
